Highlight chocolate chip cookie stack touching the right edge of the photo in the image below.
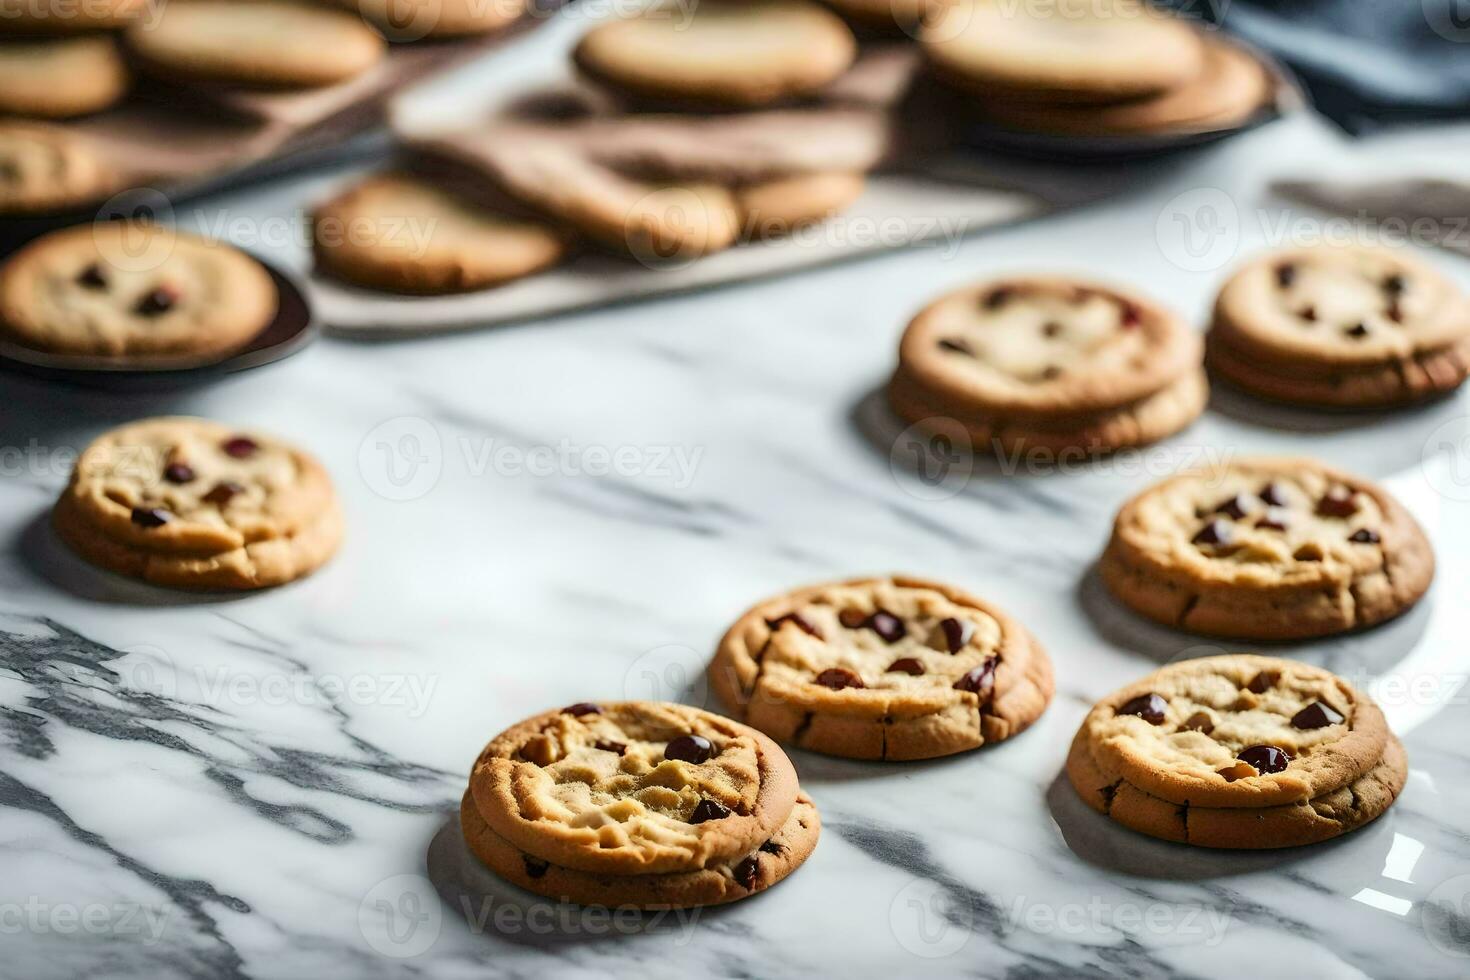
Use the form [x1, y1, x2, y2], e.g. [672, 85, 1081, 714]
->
[1207, 245, 1470, 408]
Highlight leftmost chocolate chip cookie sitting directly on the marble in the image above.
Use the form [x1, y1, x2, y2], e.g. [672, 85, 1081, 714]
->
[54, 417, 341, 589]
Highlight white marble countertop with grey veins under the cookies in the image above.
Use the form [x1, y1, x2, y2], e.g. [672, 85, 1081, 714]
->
[0, 38, 1470, 979]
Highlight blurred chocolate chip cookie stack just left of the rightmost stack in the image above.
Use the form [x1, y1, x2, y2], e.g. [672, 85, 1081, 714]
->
[888, 278, 1208, 455]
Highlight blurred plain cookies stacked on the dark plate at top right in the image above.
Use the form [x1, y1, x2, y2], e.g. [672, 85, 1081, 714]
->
[919, 0, 1273, 137]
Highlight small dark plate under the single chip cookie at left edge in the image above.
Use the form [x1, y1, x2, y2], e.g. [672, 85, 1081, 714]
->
[0, 259, 320, 391]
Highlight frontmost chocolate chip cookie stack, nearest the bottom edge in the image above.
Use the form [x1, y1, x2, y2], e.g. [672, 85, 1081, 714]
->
[460, 701, 822, 908]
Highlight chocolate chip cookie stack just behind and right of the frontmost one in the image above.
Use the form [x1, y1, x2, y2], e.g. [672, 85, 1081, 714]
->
[709, 577, 1053, 760]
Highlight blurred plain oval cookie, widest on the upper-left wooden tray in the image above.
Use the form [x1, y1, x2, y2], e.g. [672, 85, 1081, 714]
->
[125, 0, 385, 88]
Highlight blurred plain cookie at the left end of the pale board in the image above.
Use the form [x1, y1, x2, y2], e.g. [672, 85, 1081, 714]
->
[312, 173, 567, 294]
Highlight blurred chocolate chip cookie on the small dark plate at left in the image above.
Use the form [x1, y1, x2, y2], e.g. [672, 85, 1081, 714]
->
[0, 220, 278, 361]
